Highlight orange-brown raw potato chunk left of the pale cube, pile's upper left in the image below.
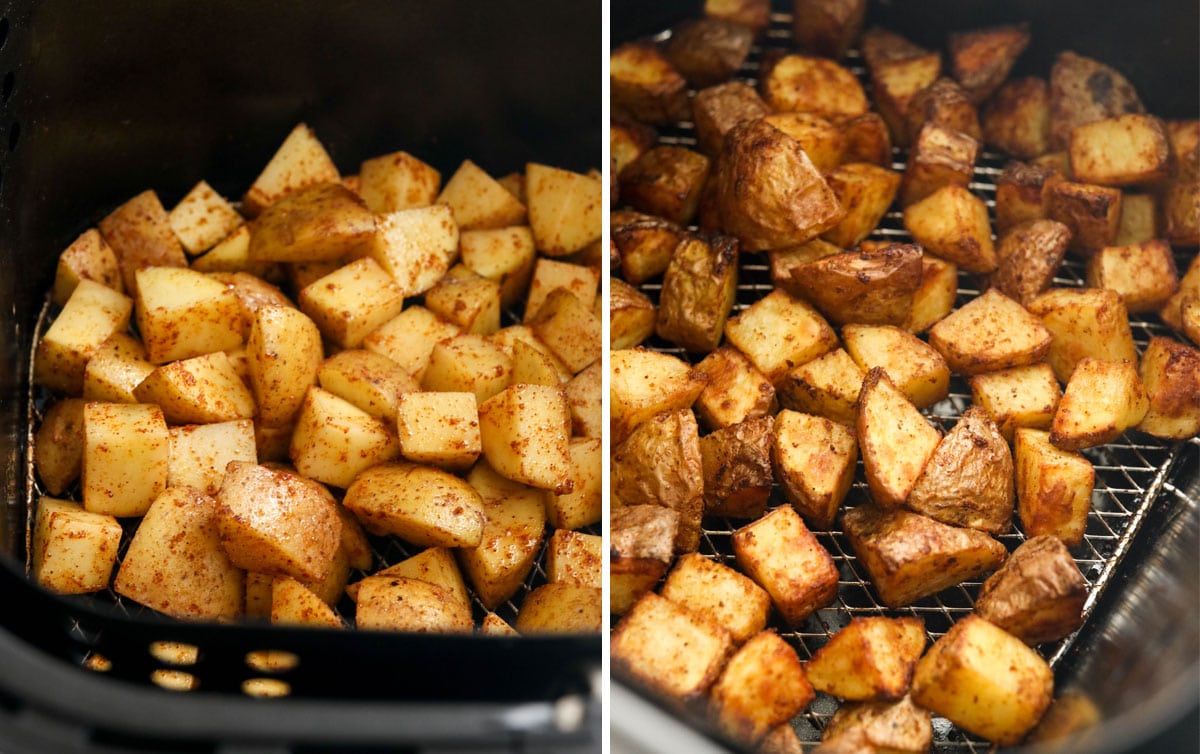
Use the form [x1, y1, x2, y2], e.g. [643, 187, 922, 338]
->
[100, 191, 187, 295]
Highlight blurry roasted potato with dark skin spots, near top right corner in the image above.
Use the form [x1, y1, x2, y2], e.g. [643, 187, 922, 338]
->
[1050, 50, 1145, 149]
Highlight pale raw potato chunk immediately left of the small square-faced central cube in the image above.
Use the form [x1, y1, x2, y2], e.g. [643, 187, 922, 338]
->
[288, 387, 400, 489]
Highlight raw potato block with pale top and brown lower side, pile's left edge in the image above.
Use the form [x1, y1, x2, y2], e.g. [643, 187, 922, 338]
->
[34, 280, 133, 395]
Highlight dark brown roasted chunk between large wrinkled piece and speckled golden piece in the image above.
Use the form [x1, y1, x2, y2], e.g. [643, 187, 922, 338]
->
[700, 417, 774, 519]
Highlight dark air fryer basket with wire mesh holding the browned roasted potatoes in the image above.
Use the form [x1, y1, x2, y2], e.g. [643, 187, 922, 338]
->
[611, 0, 1200, 754]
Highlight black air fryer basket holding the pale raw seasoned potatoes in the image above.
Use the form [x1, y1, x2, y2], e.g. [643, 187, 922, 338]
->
[0, 0, 602, 752]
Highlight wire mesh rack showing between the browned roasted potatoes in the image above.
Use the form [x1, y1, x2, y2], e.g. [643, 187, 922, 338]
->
[614, 8, 1196, 753]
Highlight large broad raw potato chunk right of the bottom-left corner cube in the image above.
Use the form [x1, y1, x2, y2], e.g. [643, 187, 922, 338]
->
[113, 487, 245, 621]
